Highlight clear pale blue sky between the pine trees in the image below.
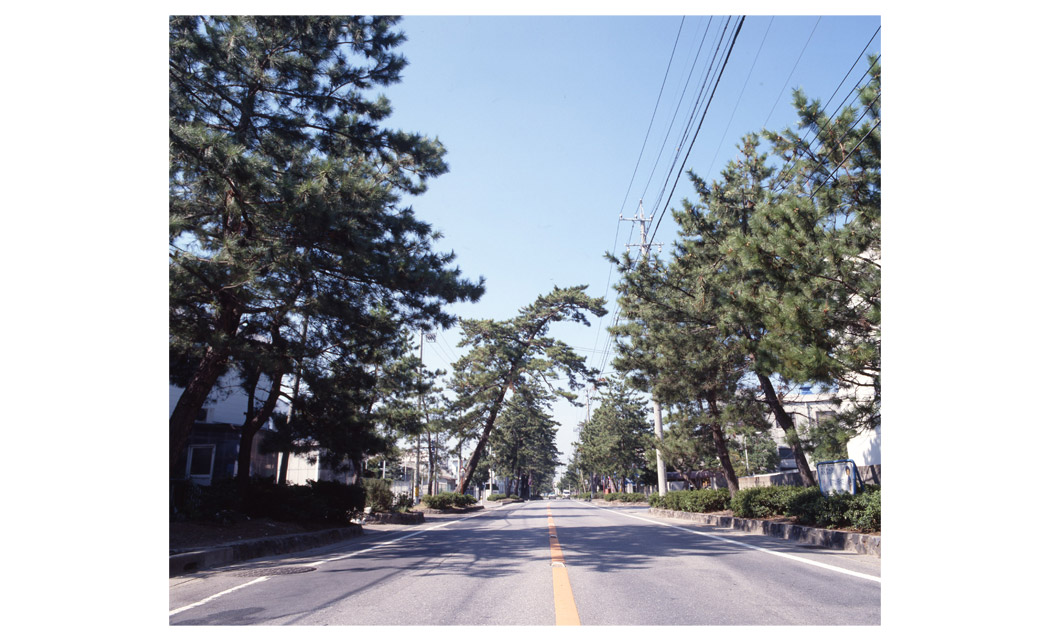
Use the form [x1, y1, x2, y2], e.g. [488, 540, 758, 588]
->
[373, 15, 881, 465]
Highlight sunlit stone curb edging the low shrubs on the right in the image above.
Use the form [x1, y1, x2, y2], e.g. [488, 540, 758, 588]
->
[649, 507, 882, 558]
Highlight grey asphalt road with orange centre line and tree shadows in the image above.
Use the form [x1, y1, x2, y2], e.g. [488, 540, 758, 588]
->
[169, 500, 881, 625]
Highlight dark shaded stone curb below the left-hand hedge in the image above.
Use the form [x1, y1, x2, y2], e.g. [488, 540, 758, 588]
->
[168, 525, 364, 577]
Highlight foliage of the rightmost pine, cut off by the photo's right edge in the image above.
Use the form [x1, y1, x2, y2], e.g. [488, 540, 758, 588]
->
[760, 56, 882, 428]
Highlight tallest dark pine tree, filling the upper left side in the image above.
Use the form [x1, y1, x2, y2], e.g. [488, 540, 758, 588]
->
[168, 16, 483, 466]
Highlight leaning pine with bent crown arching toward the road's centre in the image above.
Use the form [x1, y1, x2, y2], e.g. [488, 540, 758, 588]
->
[450, 286, 606, 493]
